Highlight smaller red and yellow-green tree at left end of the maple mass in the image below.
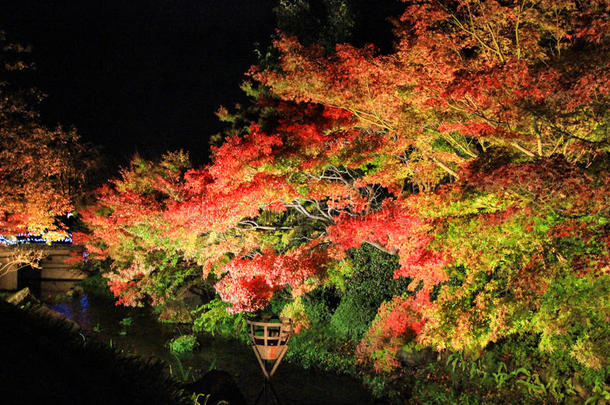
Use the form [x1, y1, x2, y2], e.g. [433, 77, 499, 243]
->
[74, 152, 192, 305]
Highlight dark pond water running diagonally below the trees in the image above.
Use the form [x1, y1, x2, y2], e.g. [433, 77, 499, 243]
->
[23, 283, 373, 404]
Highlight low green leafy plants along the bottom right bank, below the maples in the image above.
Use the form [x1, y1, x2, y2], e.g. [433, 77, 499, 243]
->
[364, 334, 609, 404]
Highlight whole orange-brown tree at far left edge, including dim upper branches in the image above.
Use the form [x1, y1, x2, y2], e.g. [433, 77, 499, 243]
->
[0, 33, 92, 239]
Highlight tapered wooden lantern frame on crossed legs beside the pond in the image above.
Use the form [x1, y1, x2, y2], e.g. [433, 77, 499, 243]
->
[248, 317, 293, 405]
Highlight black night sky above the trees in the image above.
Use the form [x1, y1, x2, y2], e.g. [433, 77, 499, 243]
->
[0, 0, 276, 164]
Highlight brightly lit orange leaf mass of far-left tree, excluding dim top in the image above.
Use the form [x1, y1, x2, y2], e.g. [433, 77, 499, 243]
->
[0, 123, 92, 235]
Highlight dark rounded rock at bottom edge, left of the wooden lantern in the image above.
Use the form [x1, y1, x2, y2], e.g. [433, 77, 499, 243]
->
[184, 370, 247, 405]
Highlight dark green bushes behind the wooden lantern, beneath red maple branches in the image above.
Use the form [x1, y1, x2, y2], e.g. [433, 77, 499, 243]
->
[258, 245, 409, 375]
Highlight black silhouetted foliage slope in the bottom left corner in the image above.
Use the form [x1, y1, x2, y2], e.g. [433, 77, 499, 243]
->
[0, 301, 190, 405]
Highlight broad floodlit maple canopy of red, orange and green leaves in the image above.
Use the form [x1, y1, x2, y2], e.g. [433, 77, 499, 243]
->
[83, 0, 610, 396]
